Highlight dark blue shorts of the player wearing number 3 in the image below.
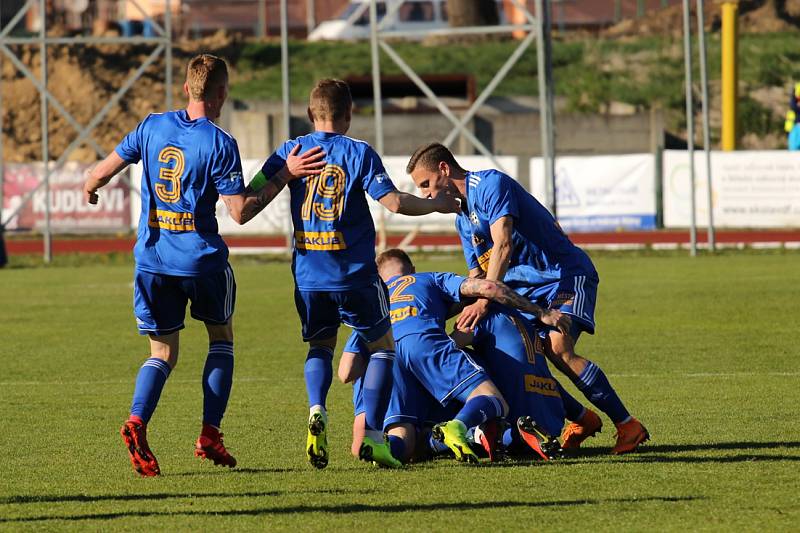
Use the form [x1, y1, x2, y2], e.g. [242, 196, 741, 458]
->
[133, 265, 236, 336]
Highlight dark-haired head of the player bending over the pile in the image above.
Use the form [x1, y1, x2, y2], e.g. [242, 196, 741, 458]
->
[406, 143, 464, 198]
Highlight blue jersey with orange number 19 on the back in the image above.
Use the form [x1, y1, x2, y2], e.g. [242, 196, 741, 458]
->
[261, 132, 396, 291]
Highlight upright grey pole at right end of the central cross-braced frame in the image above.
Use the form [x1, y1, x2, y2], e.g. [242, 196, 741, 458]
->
[536, 0, 558, 218]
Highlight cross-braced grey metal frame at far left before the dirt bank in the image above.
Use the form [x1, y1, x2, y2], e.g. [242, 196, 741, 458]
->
[0, 0, 172, 262]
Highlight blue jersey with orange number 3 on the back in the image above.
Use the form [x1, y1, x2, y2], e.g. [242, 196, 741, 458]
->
[116, 110, 244, 276]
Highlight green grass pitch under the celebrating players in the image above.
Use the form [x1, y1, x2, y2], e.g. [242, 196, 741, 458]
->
[0, 252, 800, 531]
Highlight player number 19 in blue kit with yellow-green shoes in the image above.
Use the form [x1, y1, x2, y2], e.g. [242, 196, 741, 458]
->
[250, 79, 458, 468]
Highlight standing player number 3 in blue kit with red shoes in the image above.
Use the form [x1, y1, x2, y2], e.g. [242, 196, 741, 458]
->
[84, 54, 322, 476]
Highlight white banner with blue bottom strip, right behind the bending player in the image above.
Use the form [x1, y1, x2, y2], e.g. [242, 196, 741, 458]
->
[530, 154, 656, 232]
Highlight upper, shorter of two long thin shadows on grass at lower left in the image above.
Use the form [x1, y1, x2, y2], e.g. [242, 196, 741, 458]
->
[0, 489, 362, 505]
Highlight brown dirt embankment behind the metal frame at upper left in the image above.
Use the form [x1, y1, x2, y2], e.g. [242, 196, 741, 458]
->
[0, 35, 239, 162]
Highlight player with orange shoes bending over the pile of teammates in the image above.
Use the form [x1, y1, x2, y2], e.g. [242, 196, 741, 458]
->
[406, 143, 649, 454]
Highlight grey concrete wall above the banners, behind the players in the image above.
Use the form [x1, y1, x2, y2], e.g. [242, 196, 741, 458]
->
[222, 102, 664, 182]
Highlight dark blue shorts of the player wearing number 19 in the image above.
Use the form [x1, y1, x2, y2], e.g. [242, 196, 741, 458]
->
[294, 280, 391, 342]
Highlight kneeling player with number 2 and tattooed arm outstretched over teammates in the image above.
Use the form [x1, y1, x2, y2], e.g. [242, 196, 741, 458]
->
[340, 249, 569, 462]
